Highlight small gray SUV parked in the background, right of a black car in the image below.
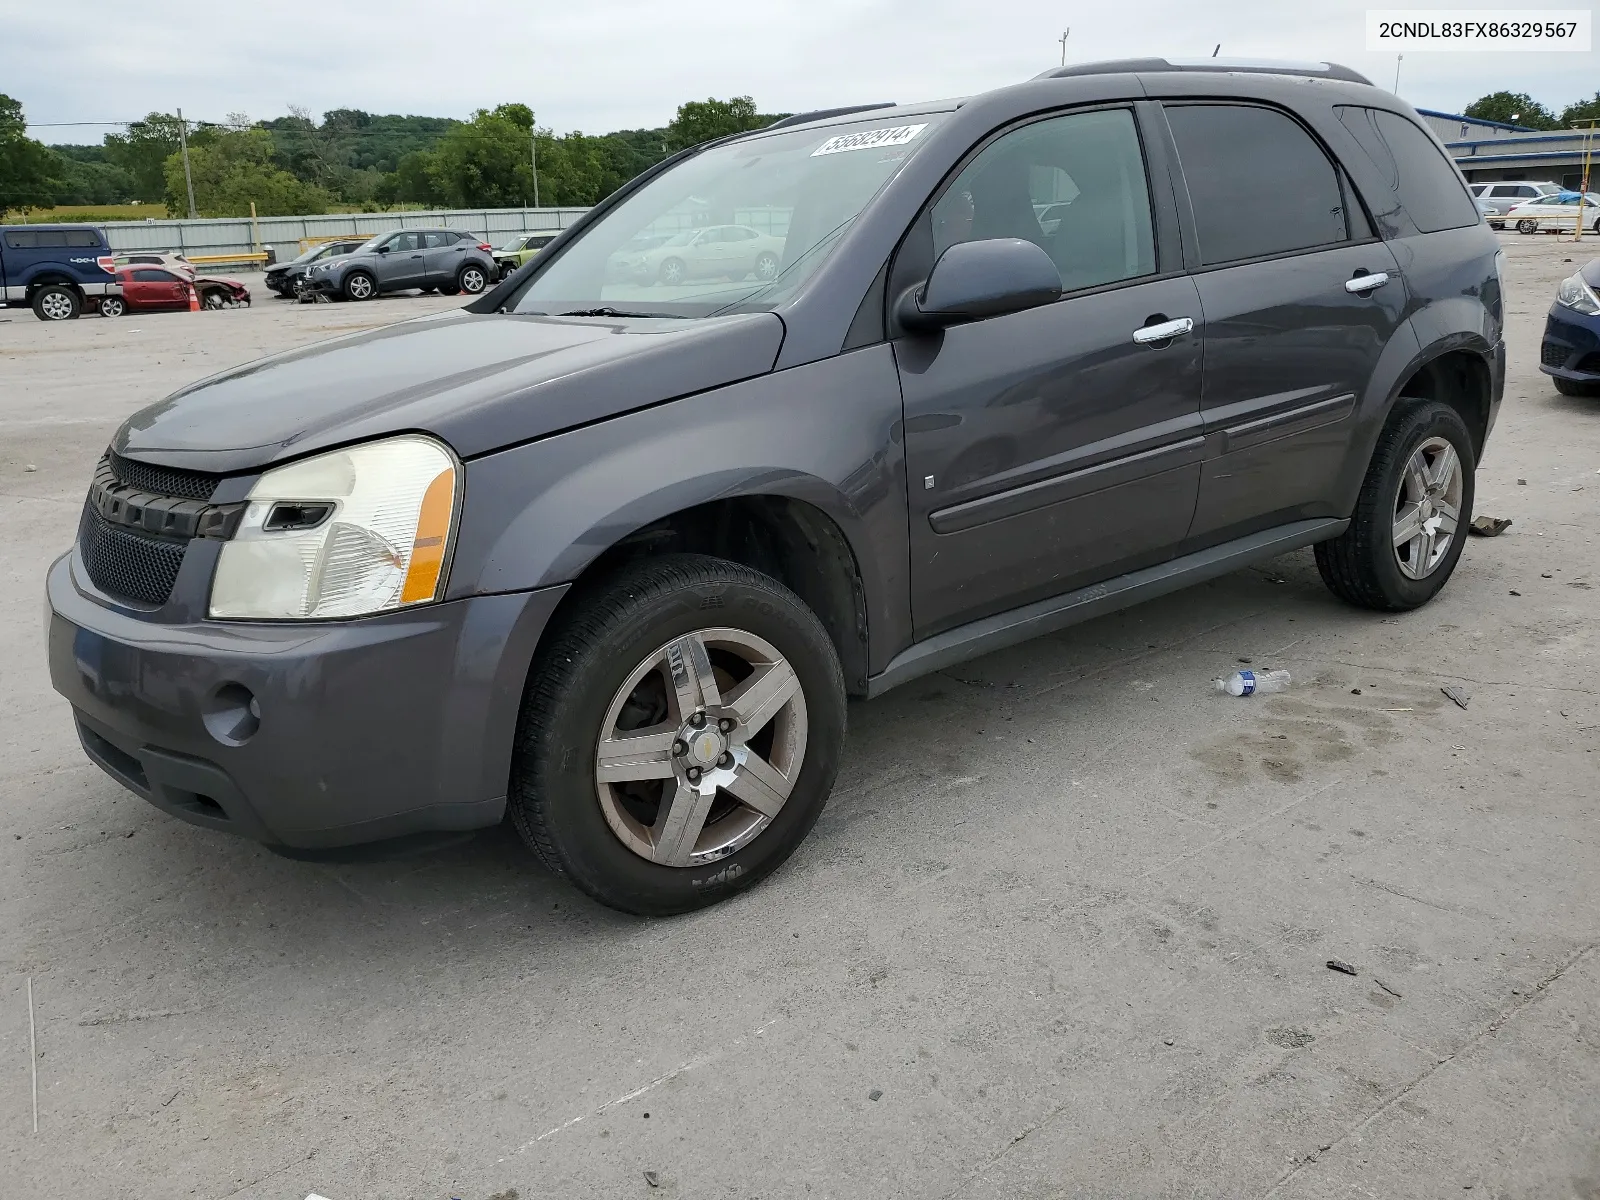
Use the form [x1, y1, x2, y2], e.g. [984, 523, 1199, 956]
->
[301, 229, 498, 301]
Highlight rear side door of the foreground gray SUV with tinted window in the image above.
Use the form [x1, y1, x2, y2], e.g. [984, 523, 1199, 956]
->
[1158, 102, 1408, 549]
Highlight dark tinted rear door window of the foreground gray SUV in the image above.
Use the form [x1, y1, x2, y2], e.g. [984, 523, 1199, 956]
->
[1166, 104, 1349, 267]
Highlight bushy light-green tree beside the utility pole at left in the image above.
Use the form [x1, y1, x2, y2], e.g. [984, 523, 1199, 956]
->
[166, 128, 331, 216]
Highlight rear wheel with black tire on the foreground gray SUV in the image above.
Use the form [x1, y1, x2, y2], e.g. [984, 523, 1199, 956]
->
[1317, 398, 1477, 613]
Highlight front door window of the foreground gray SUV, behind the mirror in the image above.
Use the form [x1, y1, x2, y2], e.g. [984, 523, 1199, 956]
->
[931, 109, 1155, 291]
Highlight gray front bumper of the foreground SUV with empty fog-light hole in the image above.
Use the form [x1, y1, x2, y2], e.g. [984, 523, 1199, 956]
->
[46, 550, 566, 850]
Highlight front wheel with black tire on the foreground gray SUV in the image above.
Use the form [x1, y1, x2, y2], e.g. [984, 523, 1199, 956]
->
[509, 554, 845, 917]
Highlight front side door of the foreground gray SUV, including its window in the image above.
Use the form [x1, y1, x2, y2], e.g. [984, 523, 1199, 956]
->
[888, 106, 1202, 638]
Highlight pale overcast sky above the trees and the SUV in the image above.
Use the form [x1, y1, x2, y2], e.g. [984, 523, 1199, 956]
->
[0, 0, 1600, 142]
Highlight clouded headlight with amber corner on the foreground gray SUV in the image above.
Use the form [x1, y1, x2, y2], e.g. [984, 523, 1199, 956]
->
[210, 434, 459, 621]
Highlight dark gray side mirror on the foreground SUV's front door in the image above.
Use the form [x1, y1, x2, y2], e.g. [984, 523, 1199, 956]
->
[896, 237, 1061, 331]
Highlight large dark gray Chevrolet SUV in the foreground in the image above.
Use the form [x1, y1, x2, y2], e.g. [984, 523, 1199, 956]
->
[48, 59, 1504, 914]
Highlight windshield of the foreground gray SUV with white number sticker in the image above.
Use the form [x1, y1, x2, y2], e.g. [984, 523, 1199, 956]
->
[515, 112, 946, 317]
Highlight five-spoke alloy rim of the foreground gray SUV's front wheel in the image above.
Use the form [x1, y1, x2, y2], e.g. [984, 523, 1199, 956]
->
[595, 629, 810, 867]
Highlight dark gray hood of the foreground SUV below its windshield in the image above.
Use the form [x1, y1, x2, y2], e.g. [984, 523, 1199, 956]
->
[112, 310, 784, 474]
